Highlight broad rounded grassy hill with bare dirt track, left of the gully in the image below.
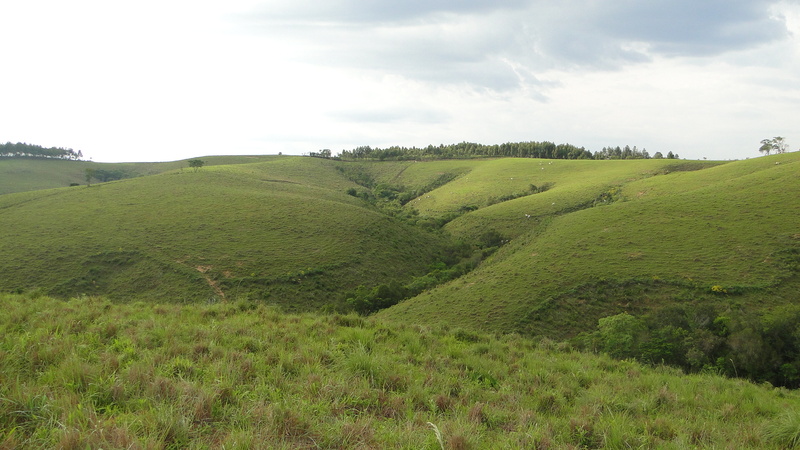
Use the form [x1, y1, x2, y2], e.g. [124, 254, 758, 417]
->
[0, 157, 456, 310]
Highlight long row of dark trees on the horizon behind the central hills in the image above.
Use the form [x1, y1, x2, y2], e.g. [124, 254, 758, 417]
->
[332, 141, 678, 161]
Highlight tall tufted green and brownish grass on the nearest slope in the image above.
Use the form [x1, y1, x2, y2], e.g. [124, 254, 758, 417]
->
[0, 294, 800, 449]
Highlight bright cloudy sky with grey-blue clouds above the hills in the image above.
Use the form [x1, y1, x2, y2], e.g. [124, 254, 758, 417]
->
[0, 0, 800, 162]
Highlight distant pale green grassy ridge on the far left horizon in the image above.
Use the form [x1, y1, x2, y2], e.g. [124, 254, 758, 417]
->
[0, 156, 277, 195]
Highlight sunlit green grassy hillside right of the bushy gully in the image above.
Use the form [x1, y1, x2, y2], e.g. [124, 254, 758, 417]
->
[380, 153, 800, 338]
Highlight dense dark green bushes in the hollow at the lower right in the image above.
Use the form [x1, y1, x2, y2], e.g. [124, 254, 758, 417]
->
[577, 305, 800, 388]
